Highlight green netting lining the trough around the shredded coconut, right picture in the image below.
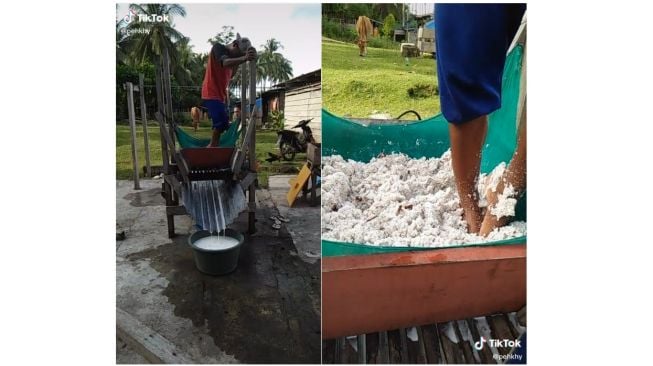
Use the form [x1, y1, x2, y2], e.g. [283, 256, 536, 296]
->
[322, 46, 526, 256]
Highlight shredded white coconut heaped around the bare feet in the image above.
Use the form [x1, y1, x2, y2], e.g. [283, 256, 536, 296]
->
[321, 151, 526, 247]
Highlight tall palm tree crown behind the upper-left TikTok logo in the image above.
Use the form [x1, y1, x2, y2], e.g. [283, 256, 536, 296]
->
[127, 4, 186, 64]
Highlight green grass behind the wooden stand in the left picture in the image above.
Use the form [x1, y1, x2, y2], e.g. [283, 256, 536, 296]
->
[116, 121, 306, 187]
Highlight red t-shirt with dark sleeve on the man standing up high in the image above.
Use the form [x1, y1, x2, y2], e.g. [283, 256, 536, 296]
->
[202, 43, 233, 103]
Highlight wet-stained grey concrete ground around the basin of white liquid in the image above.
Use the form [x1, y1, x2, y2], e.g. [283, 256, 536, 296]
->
[116, 177, 321, 363]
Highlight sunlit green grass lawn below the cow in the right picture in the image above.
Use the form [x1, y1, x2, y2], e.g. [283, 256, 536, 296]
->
[322, 38, 440, 119]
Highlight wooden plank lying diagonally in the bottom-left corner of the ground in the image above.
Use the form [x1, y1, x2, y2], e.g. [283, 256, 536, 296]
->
[116, 308, 196, 364]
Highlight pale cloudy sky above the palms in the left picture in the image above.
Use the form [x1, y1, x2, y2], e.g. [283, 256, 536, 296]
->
[117, 4, 322, 77]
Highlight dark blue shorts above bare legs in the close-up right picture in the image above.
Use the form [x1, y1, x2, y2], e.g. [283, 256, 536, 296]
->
[435, 4, 526, 123]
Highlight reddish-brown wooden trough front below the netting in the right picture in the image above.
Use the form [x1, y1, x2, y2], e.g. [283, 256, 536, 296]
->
[322, 242, 526, 339]
